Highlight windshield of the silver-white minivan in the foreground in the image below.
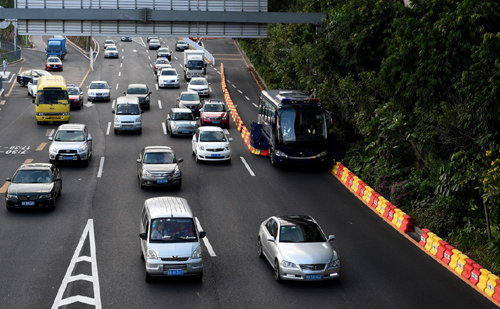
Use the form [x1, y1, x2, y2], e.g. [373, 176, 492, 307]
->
[150, 218, 198, 242]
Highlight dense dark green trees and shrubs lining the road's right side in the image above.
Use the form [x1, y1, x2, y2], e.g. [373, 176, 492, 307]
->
[240, 0, 500, 273]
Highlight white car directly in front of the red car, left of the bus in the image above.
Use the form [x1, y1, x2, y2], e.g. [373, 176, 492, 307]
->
[191, 126, 233, 163]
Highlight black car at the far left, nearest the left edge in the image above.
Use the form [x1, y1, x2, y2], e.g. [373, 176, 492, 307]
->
[5, 163, 62, 210]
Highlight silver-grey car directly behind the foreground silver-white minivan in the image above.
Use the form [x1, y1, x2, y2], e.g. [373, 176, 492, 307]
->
[137, 146, 182, 189]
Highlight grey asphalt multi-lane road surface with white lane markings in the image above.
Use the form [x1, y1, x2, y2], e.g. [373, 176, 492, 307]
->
[0, 37, 495, 308]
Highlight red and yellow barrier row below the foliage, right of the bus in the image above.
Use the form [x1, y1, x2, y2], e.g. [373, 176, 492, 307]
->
[330, 163, 500, 304]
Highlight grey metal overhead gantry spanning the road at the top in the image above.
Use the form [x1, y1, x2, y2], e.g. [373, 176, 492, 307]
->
[0, 0, 326, 38]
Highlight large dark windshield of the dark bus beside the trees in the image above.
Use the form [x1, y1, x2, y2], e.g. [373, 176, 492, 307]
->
[277, 107, 328, 145]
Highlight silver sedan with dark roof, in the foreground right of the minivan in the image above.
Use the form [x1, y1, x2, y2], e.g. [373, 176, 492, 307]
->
[257, 215, 340, 282]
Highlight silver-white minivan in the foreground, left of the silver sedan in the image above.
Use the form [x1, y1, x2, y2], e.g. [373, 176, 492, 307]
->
[139, 196, 206, 282]
